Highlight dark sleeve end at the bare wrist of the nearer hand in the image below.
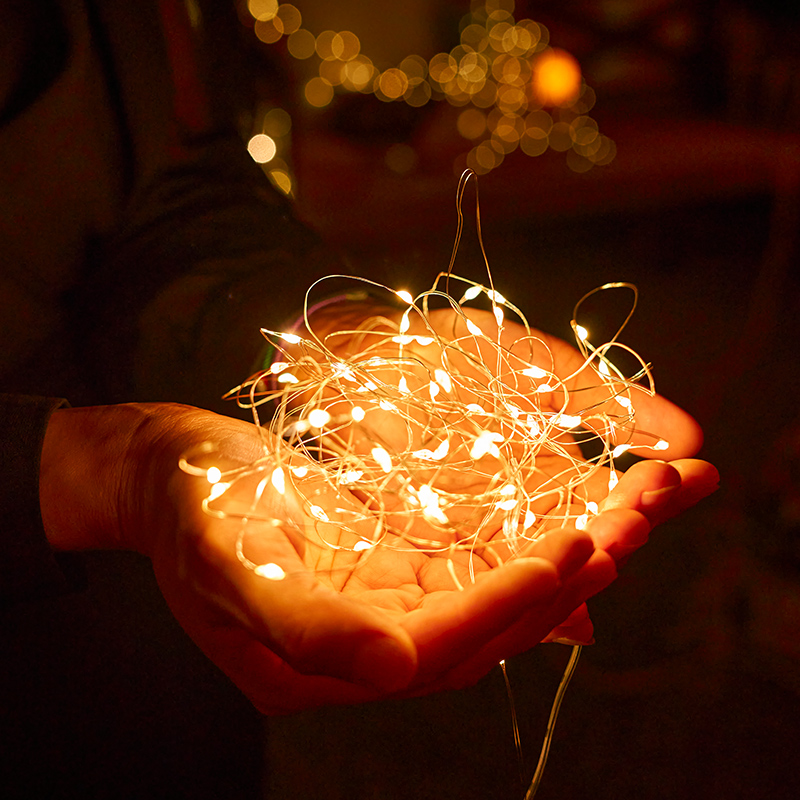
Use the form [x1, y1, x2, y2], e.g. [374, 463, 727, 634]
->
[0, 394, 83, 603]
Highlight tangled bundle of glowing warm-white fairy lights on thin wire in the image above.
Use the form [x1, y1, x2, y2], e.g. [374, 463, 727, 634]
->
[183, 222, 668, 588]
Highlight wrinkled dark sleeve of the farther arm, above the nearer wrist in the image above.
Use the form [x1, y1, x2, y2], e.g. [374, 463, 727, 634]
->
[71, 136, 341, 413]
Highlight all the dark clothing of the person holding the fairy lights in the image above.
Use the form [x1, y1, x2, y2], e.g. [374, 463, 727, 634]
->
[0, 0, 324, 798]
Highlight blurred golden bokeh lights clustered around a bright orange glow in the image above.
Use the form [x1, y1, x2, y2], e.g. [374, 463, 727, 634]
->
[241, 0, 616, 177]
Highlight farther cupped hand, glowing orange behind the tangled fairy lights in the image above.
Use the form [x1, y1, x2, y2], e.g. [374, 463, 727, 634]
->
[276, 311, 700, 564]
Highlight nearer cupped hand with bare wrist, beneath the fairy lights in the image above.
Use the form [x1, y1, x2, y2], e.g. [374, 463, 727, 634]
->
[36, 405, 712, 713]
